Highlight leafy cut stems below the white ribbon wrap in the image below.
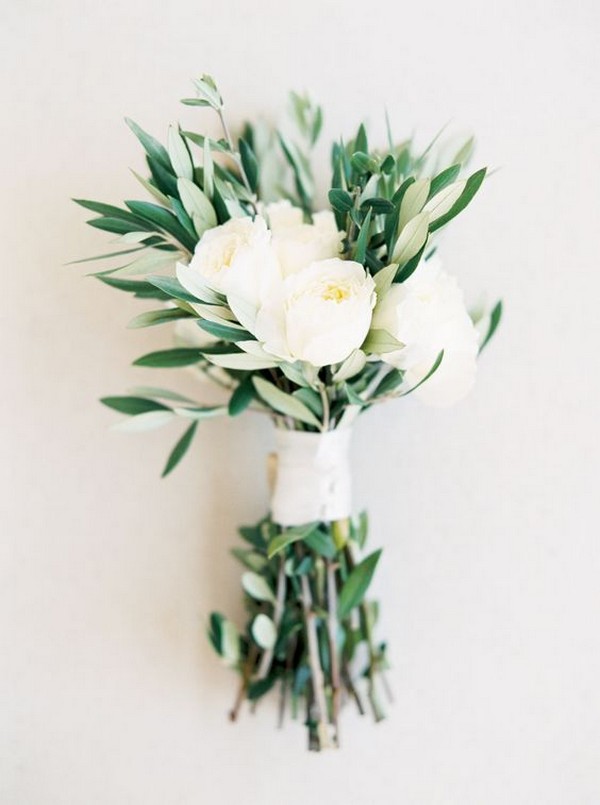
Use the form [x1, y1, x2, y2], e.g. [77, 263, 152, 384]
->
[210, 514, 391, 751]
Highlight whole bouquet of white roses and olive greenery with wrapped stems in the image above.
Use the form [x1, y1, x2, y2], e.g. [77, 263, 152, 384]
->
[77, 76, 501, 750]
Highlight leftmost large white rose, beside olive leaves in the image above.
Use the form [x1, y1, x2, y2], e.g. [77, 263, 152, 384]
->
[189, 216, 279, 307]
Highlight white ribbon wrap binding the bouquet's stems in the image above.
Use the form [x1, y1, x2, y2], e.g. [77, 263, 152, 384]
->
[271, 428, 352, 526]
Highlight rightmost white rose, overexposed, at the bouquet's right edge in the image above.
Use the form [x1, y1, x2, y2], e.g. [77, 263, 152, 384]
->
[373, 257, 478, 406]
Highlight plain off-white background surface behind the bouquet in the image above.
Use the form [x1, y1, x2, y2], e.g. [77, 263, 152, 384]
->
[0, 0, 600, 805]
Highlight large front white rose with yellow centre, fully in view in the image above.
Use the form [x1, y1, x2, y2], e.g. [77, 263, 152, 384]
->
[254, 258, 375, 366]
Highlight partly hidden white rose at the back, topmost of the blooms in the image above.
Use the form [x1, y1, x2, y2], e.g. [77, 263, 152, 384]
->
[265, 201, 344, 277]
